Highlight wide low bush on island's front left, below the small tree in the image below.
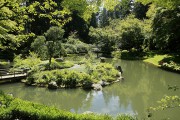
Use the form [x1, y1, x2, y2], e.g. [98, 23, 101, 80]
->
[27, 70, 92, 88]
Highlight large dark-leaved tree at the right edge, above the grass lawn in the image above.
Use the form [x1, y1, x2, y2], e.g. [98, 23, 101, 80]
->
[152, 8, 180, 52]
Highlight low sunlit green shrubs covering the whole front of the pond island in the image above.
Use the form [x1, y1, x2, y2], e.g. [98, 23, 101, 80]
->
[26, 63, 120, 88]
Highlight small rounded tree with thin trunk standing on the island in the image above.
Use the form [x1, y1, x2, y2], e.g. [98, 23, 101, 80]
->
[45, 26, 64, 68]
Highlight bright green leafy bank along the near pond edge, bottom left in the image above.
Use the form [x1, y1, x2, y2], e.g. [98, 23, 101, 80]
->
[0, 92, 136, 120]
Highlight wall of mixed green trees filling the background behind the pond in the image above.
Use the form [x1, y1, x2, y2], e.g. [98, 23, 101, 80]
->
[0, 0, 180, 59]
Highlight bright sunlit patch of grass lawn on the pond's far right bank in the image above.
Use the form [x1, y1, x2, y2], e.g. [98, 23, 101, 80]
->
[143, 55, 170, 67]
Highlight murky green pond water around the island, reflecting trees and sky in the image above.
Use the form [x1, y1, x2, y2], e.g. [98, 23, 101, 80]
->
[0, 60, 180, 120]
